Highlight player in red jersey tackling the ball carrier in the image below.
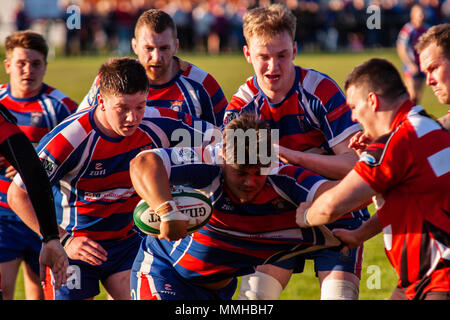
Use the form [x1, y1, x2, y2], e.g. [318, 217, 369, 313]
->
[297, 59, 450, 300]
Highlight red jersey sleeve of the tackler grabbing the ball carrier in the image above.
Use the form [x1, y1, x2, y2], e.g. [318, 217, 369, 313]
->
[354, 132, 413, 193]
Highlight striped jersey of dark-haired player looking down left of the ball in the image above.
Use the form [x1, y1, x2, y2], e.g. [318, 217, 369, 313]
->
[15, 107, 216, 240]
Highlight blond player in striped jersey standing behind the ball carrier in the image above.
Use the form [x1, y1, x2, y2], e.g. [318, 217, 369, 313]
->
[224, 4, 369, 299]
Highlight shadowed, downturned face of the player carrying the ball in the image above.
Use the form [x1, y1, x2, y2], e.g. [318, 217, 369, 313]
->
[223, 164, 267, 203]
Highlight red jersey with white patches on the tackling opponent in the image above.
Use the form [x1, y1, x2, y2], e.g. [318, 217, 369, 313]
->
[354, 102, 450, 299]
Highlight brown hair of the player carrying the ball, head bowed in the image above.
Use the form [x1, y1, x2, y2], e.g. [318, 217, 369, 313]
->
[222, 112, 274, 169]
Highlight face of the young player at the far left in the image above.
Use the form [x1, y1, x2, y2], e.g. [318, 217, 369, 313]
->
[4, 47, 47, 98]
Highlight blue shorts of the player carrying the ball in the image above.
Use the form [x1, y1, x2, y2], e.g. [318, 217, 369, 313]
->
[130, 241, 237, 300]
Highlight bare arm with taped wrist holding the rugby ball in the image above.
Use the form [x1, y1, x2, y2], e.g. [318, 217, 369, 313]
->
[130, 152, 188, 241]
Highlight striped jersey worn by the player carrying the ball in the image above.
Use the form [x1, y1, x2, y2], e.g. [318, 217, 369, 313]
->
[135, 146, 360, 283]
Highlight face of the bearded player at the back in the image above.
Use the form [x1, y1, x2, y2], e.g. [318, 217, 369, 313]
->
[132, 27, 178, 85]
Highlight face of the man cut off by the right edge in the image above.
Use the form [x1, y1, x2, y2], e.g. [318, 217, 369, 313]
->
[419, 43, 450, 104]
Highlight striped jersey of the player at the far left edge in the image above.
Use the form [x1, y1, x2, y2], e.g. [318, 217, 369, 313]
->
[0, 83, 77, 217]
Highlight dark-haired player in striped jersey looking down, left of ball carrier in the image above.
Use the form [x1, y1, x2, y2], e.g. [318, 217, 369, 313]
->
[9, 58, 212, 300]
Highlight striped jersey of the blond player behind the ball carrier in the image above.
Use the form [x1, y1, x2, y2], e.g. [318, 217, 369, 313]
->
[224, 66, 361, 152]
